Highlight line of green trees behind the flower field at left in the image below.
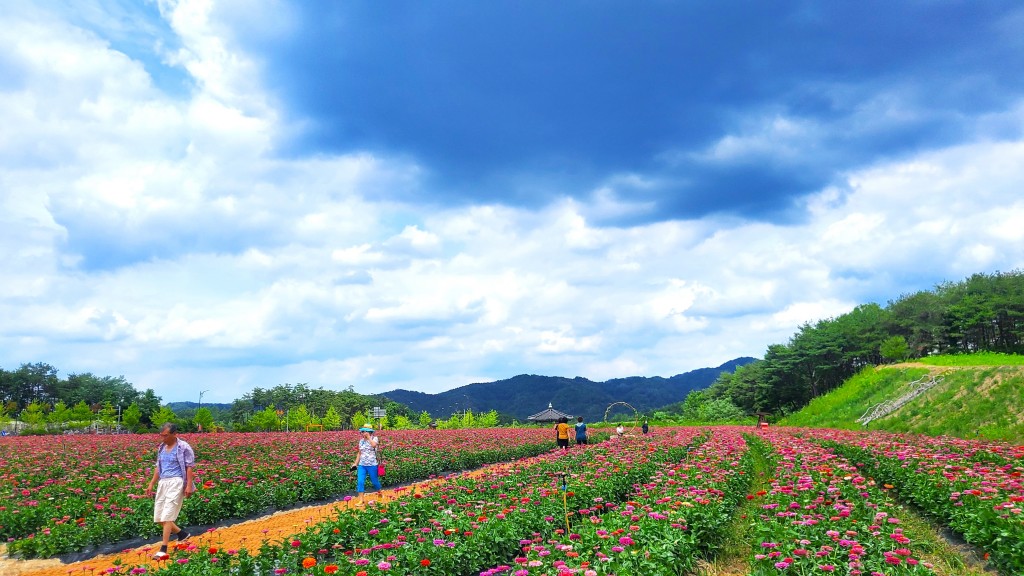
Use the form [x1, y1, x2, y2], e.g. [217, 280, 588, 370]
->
[0, 363, 499, 434]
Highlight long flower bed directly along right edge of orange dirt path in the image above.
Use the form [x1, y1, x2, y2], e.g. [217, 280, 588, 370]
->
[108, 429, 718, 576]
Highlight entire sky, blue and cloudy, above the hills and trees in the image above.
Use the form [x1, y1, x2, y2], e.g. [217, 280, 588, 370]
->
[0, 0, 1024, 402]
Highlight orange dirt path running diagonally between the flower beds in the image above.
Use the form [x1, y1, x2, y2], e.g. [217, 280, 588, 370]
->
[0, 462, 524, 576]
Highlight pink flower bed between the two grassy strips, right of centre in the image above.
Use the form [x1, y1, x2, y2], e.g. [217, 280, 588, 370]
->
[749, 429, 934, 576]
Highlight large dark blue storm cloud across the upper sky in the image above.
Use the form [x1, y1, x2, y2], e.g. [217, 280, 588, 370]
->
[243, 2, 1024, 219]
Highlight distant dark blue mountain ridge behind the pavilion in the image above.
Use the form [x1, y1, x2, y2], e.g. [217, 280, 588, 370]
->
[381, 357, 757, 421]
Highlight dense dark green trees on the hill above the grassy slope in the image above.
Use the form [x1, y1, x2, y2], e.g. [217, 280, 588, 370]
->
[694, 271, 1024, 414]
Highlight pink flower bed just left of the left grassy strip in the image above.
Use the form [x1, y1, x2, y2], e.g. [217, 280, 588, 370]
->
[480, 428, 750, 576]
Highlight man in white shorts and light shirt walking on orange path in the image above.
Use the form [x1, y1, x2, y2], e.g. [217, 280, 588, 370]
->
[145, 422, 196, 560]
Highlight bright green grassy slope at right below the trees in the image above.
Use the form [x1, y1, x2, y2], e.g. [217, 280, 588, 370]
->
[779, 355, 1024, 442]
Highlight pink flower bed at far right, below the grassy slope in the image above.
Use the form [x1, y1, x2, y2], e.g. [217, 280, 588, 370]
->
[808, 424, 1024, 574]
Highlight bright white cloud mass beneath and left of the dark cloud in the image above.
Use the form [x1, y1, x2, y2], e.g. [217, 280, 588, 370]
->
[0, 0, 1024, 402]
